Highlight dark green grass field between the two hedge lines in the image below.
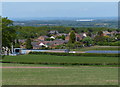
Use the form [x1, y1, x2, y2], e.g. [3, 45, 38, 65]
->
[2, 55, 118, 64]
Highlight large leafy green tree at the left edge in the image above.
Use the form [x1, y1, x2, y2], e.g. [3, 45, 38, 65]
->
[2, 17, 16, 54]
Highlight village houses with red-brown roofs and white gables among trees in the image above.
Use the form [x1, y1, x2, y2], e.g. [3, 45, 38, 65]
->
[19, 31, 118, 49]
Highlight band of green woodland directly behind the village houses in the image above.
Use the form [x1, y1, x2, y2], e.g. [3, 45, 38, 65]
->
[16, 26, 118, 39]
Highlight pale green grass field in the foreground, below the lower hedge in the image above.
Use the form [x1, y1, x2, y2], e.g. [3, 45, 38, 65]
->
[2, 64, 118, 85]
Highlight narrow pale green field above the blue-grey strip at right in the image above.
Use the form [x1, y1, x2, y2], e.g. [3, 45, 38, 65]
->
[71, 46, 119, 51]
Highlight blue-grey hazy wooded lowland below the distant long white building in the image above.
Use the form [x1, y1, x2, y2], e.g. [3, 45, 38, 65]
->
[14, 19, 118, 28]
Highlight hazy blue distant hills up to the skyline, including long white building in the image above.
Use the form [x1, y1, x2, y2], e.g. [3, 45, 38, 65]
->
[14, 17, 118, 28]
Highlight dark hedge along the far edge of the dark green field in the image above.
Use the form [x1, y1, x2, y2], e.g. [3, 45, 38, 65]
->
[29, 52, 120, 57]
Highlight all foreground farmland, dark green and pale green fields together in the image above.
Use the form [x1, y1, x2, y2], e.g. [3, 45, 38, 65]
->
[2, 54, 118, 85]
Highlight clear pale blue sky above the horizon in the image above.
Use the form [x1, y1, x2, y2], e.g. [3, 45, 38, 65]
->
[2, 2, 118, 18]
